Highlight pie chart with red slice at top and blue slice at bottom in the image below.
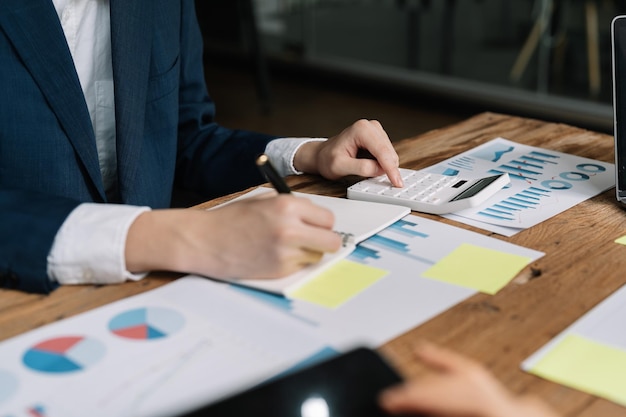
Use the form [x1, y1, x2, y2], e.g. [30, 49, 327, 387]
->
[22, 336, 105, 374]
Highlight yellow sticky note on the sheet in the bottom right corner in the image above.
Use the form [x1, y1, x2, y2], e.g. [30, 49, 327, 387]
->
[530, 334, 626, 406]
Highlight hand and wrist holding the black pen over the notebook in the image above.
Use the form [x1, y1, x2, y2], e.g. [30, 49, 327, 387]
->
[126, 193, 341, 279]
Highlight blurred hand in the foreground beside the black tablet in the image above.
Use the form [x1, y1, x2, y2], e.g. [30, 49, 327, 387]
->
[379, 343, 558, 417]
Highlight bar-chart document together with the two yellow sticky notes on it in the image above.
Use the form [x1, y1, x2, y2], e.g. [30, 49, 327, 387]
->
[221, 215, 543, 350]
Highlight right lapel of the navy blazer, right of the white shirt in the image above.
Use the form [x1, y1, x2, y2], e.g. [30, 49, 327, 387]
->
[109, 0, 154, 201]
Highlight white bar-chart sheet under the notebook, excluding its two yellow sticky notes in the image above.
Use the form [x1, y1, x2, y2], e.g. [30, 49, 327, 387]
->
[216, 215, 543, 348]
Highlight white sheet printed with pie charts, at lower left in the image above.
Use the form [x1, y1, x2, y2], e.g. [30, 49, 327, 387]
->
[0, 277, 332, 417]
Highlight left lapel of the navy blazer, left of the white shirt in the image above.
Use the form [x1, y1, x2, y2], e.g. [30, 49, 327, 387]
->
[0, 0, 105, 201]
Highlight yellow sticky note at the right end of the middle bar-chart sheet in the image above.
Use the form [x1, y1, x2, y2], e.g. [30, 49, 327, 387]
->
[422, 243, 532, 294]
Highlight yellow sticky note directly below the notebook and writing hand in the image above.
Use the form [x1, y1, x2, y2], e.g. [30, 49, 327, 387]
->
[289, 259, 387, 308]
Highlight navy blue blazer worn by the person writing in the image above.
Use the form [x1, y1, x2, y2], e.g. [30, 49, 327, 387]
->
[0, 0, 274, 292]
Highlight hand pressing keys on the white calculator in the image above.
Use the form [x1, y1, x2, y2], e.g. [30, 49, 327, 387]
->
[294, 120, 402, 187]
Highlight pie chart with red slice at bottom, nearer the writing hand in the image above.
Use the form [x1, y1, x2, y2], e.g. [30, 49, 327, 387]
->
[109, 307, 185, 340]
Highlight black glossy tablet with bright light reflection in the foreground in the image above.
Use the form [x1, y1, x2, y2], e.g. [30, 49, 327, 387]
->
[177, 348, 401, 417]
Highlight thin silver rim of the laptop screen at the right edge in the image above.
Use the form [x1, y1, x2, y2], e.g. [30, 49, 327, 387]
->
[611, 16, 626, 205]
